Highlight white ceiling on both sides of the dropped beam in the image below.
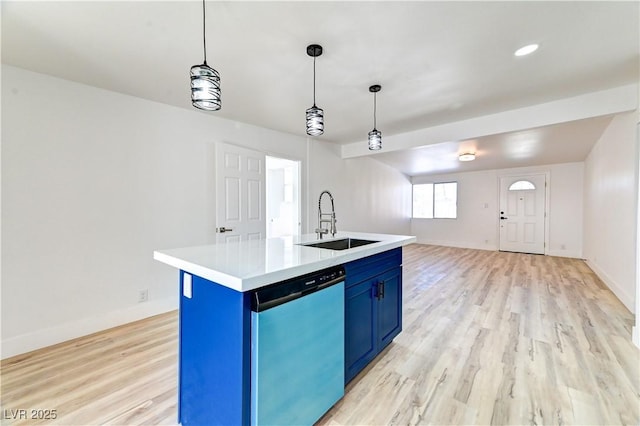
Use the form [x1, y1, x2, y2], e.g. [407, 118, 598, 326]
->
[2, 0, 640, 175]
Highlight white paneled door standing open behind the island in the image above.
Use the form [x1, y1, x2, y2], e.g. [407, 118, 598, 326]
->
[216, 143, 266, 242]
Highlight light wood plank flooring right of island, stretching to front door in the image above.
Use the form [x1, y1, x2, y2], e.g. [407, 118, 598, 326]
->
[319, 245, 640, 425]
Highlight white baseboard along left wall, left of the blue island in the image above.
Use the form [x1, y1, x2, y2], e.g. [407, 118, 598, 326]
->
[1, 298, 178, 359]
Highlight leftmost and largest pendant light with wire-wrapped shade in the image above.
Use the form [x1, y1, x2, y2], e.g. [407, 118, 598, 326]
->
[191, 0, 222, 111]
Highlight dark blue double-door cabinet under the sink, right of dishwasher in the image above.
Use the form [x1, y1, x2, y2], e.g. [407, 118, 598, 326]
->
[344, 248, 402, 383]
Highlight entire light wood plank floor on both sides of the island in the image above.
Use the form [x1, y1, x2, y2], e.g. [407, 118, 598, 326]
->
[1, 245, 640, 425]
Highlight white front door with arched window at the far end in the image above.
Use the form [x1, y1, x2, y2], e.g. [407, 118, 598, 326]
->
[500, 174, 546, 254]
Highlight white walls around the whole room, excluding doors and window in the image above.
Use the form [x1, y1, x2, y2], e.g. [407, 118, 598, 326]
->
[6, 65, 638, 358]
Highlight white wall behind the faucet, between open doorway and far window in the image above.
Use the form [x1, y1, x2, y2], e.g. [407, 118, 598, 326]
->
[307, 140, 411, 235]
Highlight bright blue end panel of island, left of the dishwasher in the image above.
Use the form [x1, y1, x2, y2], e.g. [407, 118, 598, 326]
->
[178, 271, 251, 426]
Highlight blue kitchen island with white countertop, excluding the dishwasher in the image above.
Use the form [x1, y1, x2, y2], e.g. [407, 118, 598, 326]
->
[154, 232, 415, 425]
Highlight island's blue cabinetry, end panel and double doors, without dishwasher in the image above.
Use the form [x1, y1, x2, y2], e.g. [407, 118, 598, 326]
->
[178, 248, 402, 426]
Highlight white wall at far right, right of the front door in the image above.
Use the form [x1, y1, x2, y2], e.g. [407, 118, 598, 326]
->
[584, 113, 638, 312]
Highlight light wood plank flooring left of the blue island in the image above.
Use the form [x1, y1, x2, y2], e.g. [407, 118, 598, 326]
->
[1, 311, 178, 425]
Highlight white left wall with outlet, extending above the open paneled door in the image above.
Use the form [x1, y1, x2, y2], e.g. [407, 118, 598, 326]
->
[2, 65, 307, 358]
